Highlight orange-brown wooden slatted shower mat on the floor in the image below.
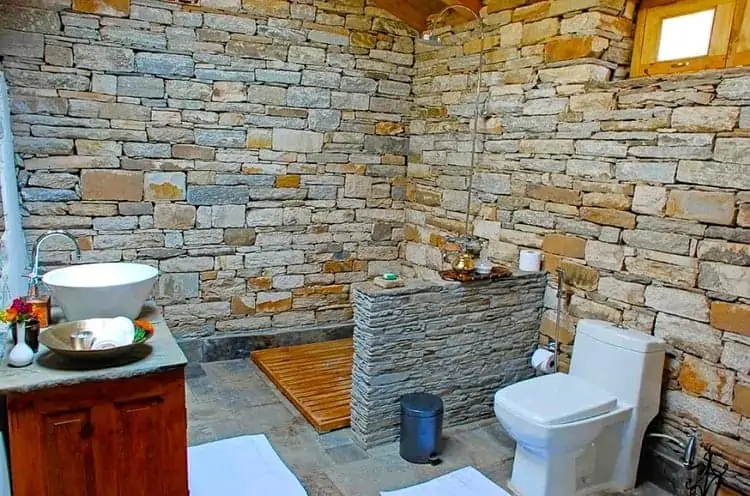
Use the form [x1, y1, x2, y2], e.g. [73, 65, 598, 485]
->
[250, 338, 354, 432]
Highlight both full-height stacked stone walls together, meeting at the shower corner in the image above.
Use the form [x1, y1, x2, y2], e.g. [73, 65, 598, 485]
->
[0, 0, 750, 490]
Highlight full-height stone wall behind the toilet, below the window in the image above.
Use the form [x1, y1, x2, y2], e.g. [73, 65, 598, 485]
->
[405, 0, 750, 490]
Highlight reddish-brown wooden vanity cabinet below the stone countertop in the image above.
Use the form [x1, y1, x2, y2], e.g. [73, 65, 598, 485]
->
[7, 367, 188, 496]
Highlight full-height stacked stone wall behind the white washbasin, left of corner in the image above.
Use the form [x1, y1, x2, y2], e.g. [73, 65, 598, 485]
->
[0, 0, 413, 355]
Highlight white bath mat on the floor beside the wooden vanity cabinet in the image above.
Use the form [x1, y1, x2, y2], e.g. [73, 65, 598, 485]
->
[188, 434, 307, 496]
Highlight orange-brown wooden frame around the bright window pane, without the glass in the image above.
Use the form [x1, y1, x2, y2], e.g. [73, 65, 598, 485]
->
[630, 0, 750, 77]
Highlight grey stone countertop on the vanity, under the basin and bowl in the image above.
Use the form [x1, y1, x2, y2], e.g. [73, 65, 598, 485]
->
[0, 307, 187, 394]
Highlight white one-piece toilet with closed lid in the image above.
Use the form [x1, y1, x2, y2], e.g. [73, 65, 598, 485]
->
[495, 320, 666, 496]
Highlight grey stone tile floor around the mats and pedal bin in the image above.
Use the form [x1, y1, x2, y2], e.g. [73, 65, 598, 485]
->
[186, 360, 667, 496]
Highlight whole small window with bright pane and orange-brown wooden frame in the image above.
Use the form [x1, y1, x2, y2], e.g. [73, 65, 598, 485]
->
[630, 0, 750, 77]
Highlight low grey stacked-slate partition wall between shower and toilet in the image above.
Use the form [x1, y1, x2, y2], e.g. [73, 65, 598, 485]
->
[351, 273, 547, 448]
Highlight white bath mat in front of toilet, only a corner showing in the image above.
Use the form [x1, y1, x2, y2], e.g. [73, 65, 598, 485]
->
[380, 467, 511, 496]
